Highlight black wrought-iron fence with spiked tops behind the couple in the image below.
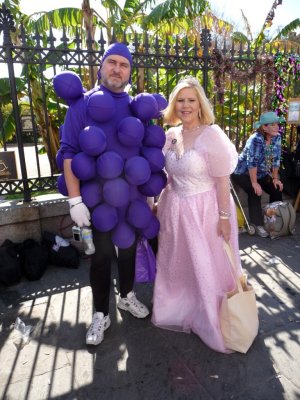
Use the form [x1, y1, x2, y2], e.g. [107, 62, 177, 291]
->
[0, 5, 300, 201]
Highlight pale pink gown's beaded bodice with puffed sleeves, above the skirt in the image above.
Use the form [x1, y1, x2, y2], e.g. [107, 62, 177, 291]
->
[164, 125, 238, 197]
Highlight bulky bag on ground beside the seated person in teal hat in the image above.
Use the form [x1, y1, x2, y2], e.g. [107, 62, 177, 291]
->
[263, 201, 296, 239]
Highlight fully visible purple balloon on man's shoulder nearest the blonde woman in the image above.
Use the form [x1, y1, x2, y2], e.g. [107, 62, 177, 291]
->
[130, 93, 158, 121]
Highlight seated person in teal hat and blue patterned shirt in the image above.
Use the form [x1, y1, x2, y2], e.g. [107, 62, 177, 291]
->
[231, 111, 284, 237]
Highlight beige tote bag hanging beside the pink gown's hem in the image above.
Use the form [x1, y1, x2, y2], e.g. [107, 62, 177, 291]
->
[220, 242, 259, 353]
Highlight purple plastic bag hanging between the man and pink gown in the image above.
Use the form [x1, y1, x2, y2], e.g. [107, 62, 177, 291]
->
[135, 238, 156, 283]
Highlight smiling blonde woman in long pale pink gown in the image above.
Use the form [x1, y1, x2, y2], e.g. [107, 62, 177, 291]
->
[152, 76, 241, 353]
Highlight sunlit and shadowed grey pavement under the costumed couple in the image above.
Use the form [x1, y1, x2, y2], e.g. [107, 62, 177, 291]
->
[0, 219, 300, 400]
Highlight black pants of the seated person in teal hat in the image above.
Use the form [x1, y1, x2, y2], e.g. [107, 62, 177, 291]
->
[231, 174, 282, 225]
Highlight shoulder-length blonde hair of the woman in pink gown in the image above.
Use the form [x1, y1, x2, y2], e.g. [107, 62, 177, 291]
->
[163, 76, 215, 126]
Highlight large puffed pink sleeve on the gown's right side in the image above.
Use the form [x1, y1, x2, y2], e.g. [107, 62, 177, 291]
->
[201, 125, 238, 178]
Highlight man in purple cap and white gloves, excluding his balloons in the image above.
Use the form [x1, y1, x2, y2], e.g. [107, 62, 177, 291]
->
[61, 43, 149, 345]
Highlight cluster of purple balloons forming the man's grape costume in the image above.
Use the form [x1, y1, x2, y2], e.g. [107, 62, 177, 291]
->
[53, 71, 167, 248]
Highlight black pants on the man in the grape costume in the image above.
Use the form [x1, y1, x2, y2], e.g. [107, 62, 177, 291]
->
[90, 229, 136, 315]
